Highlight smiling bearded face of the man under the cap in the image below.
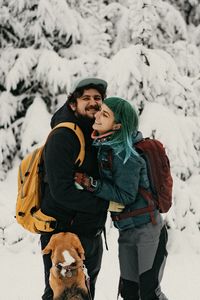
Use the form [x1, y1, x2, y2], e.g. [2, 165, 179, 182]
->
[71, 88, 102, 119]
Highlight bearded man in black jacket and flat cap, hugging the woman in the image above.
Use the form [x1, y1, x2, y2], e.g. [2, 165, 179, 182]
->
[41, 78, 108, 300]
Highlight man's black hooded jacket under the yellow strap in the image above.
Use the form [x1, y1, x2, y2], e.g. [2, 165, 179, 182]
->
[41, 104, 108, 234]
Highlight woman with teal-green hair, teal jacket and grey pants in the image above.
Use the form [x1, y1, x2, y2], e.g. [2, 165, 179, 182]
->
[76, 97, 167, 300]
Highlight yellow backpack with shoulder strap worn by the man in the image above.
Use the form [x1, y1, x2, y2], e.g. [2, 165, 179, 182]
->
[16, 122, 85, 233]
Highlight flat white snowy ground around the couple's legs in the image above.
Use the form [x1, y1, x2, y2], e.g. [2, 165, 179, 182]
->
[0, 229, 200, 300]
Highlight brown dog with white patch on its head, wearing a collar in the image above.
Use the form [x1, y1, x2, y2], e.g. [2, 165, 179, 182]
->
[42, 232, 89, 300]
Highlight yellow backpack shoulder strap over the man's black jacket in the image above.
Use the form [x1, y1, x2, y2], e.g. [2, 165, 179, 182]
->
[47, 122, 85, 167]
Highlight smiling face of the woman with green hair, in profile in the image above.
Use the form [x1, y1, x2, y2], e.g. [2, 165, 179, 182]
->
[92, 103, 121, 135]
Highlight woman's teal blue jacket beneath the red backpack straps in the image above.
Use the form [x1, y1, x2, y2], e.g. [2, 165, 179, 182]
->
[93, 132, 158, 230]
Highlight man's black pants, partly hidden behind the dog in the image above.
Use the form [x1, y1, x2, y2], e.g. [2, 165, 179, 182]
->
[40, 234, 103, 300]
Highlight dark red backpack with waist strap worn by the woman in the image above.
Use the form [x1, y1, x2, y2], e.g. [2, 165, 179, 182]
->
[112, 138, 173, 223]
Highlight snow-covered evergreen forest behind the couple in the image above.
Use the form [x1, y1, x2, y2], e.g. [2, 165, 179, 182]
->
[0, 0, 200, 298]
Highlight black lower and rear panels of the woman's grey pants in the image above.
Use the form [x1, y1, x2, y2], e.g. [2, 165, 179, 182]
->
[119, 226, 167, 300]
